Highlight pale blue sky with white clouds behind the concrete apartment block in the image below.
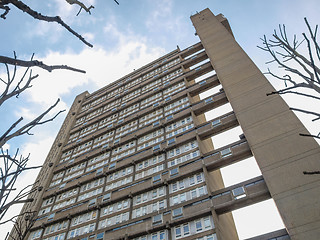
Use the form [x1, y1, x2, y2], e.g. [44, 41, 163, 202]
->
[0, 0, 320, 239]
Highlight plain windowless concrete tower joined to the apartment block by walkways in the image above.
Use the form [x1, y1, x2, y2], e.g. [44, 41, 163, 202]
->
[191, 9, 320, 239]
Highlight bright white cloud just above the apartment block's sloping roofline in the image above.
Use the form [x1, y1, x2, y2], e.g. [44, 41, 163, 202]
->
[24, 21, 165, 110]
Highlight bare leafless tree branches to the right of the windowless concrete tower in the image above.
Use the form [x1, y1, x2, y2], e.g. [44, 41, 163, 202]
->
[259, 18, 320, 175]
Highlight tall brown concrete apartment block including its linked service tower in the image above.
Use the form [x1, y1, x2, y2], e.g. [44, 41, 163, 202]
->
[11, 9, 320, 240]
